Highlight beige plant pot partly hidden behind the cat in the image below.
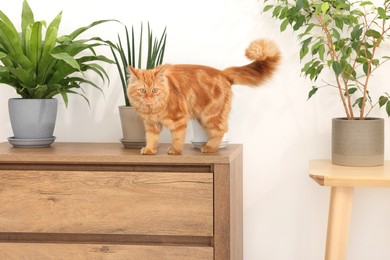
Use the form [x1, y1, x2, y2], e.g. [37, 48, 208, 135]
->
[119, 106, 146, 148]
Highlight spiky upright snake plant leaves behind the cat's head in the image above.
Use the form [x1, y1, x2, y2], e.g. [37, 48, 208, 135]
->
[111, 23, 167, 106]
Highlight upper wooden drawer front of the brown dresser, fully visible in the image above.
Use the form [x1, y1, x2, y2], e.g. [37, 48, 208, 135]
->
[0, 171, 213, 237]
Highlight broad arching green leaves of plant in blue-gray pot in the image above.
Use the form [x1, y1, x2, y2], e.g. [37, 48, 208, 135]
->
[0, 0, 113, 106]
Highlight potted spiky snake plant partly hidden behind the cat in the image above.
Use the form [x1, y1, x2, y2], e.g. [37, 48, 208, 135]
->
[111, 23, 167, 148]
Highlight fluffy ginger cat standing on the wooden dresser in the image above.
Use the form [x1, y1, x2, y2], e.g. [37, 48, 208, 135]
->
[127, 39, 280, 155]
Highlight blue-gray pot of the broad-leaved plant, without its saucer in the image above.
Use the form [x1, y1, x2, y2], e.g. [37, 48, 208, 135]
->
[8, 98, 58, 139]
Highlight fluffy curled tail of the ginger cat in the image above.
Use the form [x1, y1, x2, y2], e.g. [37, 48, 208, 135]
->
[223, 39, 280, 86]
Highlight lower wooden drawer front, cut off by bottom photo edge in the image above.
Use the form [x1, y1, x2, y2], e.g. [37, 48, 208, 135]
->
[0, 243, 213, 260]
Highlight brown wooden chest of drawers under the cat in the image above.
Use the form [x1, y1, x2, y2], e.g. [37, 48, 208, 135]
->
[0, 143, 243, 260]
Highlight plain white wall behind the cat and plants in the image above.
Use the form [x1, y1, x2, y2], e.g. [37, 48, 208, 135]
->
[0, 0, 390, 260]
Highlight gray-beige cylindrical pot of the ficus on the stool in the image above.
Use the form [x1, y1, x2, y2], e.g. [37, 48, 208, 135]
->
[332, 117, 385, 166]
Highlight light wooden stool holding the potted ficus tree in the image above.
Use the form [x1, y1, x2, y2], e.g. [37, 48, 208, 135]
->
[309, 160, 390, 260]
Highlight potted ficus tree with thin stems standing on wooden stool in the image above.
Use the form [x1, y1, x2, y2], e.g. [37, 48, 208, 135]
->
[263, 0, 390, 166]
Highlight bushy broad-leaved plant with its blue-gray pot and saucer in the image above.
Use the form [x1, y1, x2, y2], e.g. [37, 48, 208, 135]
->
[0, 1, 113, 147]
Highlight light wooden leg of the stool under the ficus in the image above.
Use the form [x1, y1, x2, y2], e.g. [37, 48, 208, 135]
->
[325, 187, 354, 260]
